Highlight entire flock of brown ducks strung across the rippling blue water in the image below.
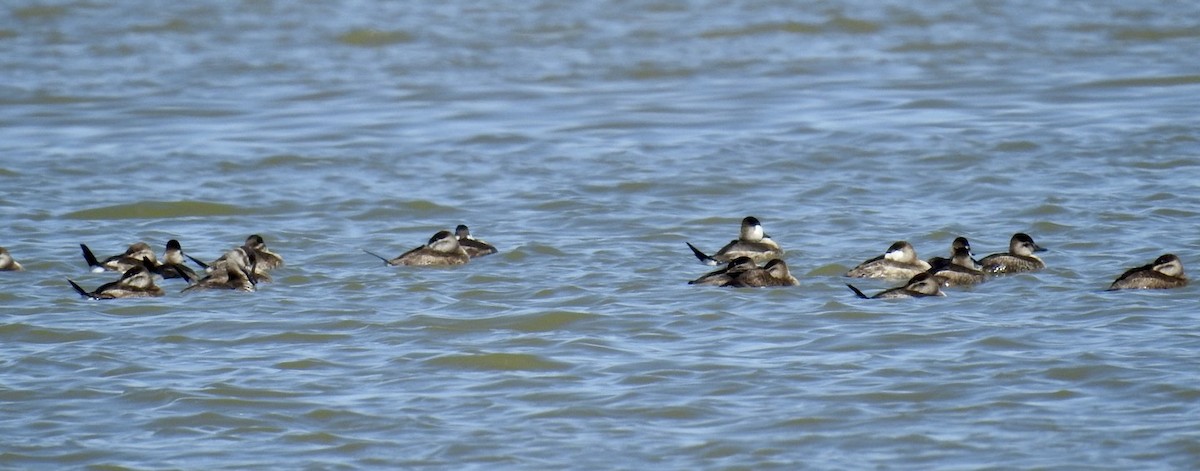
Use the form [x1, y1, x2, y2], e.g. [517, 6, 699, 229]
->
[0, 216, 1188, 299]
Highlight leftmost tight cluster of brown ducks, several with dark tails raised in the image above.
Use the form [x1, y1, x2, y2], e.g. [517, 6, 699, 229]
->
[67, 234, 283, 299]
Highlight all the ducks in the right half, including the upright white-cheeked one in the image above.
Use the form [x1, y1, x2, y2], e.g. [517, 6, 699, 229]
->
[688, 216, 1188, 299]
